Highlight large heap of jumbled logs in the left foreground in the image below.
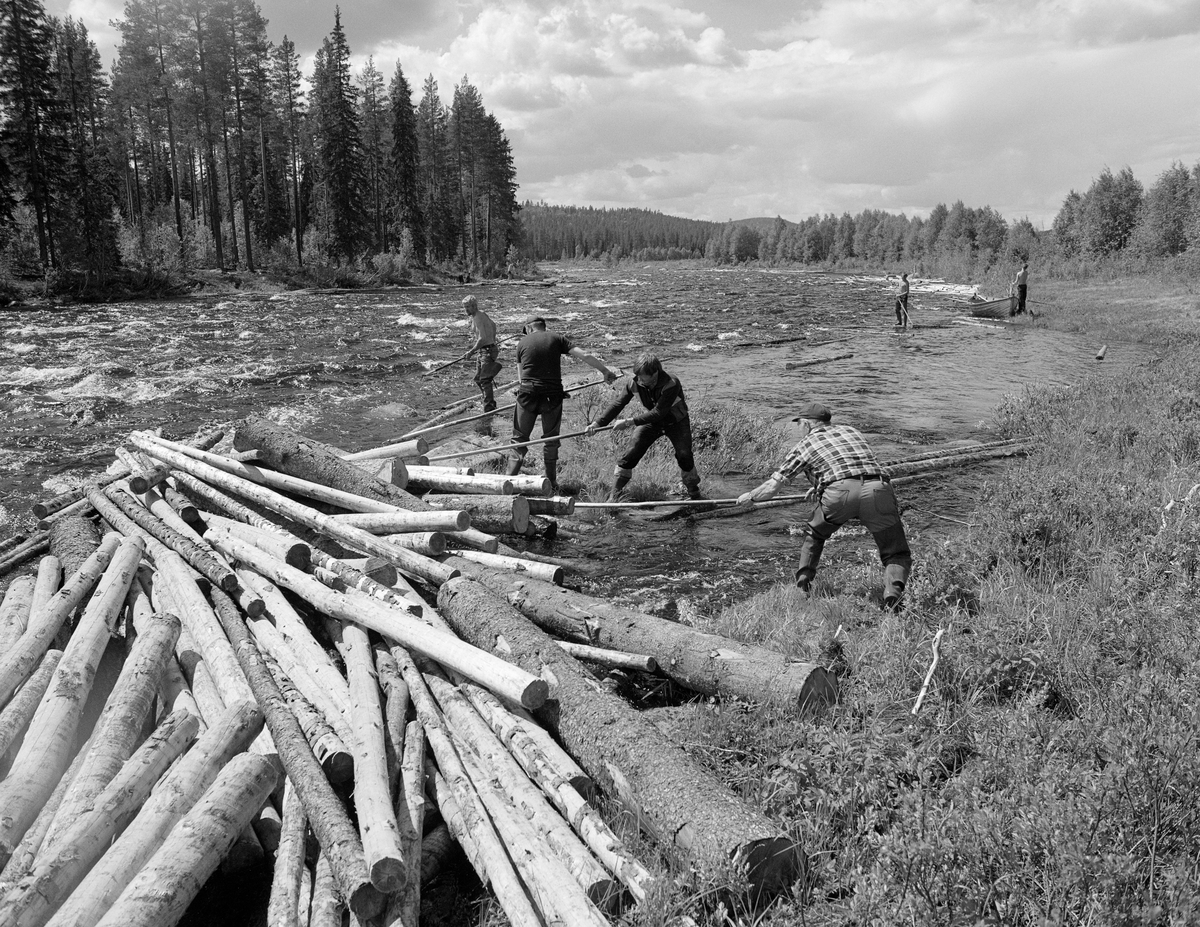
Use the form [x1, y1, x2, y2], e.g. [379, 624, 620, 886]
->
[0, 418, 836, 927]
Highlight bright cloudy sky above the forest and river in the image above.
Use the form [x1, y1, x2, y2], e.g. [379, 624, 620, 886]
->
[46, 0, 1200, 228]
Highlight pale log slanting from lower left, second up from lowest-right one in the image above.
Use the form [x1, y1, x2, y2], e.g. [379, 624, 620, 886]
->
[50, 702, 263, 927]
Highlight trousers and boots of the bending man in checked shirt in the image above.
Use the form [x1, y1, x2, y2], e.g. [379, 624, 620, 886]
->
[796, 478, 912, 597]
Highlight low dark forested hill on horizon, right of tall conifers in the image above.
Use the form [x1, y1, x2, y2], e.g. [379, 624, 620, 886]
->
[521, 202, 725, 261]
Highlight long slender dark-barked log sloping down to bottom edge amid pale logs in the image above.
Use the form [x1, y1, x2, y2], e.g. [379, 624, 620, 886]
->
[205, 578, 384, 920]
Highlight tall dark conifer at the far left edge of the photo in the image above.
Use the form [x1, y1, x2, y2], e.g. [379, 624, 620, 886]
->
[0, 0, 67, 270]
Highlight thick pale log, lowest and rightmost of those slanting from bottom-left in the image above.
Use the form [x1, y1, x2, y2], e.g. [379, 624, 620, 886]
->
[88, 754, 278, 927]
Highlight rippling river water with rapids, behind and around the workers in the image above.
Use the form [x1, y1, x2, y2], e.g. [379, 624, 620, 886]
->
[0, 265, 1146, 607]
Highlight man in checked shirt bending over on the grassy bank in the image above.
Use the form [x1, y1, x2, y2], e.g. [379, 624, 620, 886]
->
[738, 402, 912, 611]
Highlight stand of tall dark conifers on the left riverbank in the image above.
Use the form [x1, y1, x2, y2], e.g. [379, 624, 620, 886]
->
[0, 0, 521, 285]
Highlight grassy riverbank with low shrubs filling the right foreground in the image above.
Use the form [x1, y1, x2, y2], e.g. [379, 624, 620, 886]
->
[489, 281, 1200, 927]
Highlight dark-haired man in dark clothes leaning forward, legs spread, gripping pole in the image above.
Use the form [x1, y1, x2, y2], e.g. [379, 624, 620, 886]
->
[588, 354, 704, 502]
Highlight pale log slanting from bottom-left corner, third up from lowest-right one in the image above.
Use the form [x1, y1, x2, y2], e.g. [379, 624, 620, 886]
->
[0, 712, 199, 927]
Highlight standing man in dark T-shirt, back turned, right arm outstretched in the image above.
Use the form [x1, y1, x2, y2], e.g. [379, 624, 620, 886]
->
[508, 317, 620, 492]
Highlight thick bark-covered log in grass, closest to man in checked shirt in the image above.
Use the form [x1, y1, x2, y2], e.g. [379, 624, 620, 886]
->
[448, 566, 838, 710]
